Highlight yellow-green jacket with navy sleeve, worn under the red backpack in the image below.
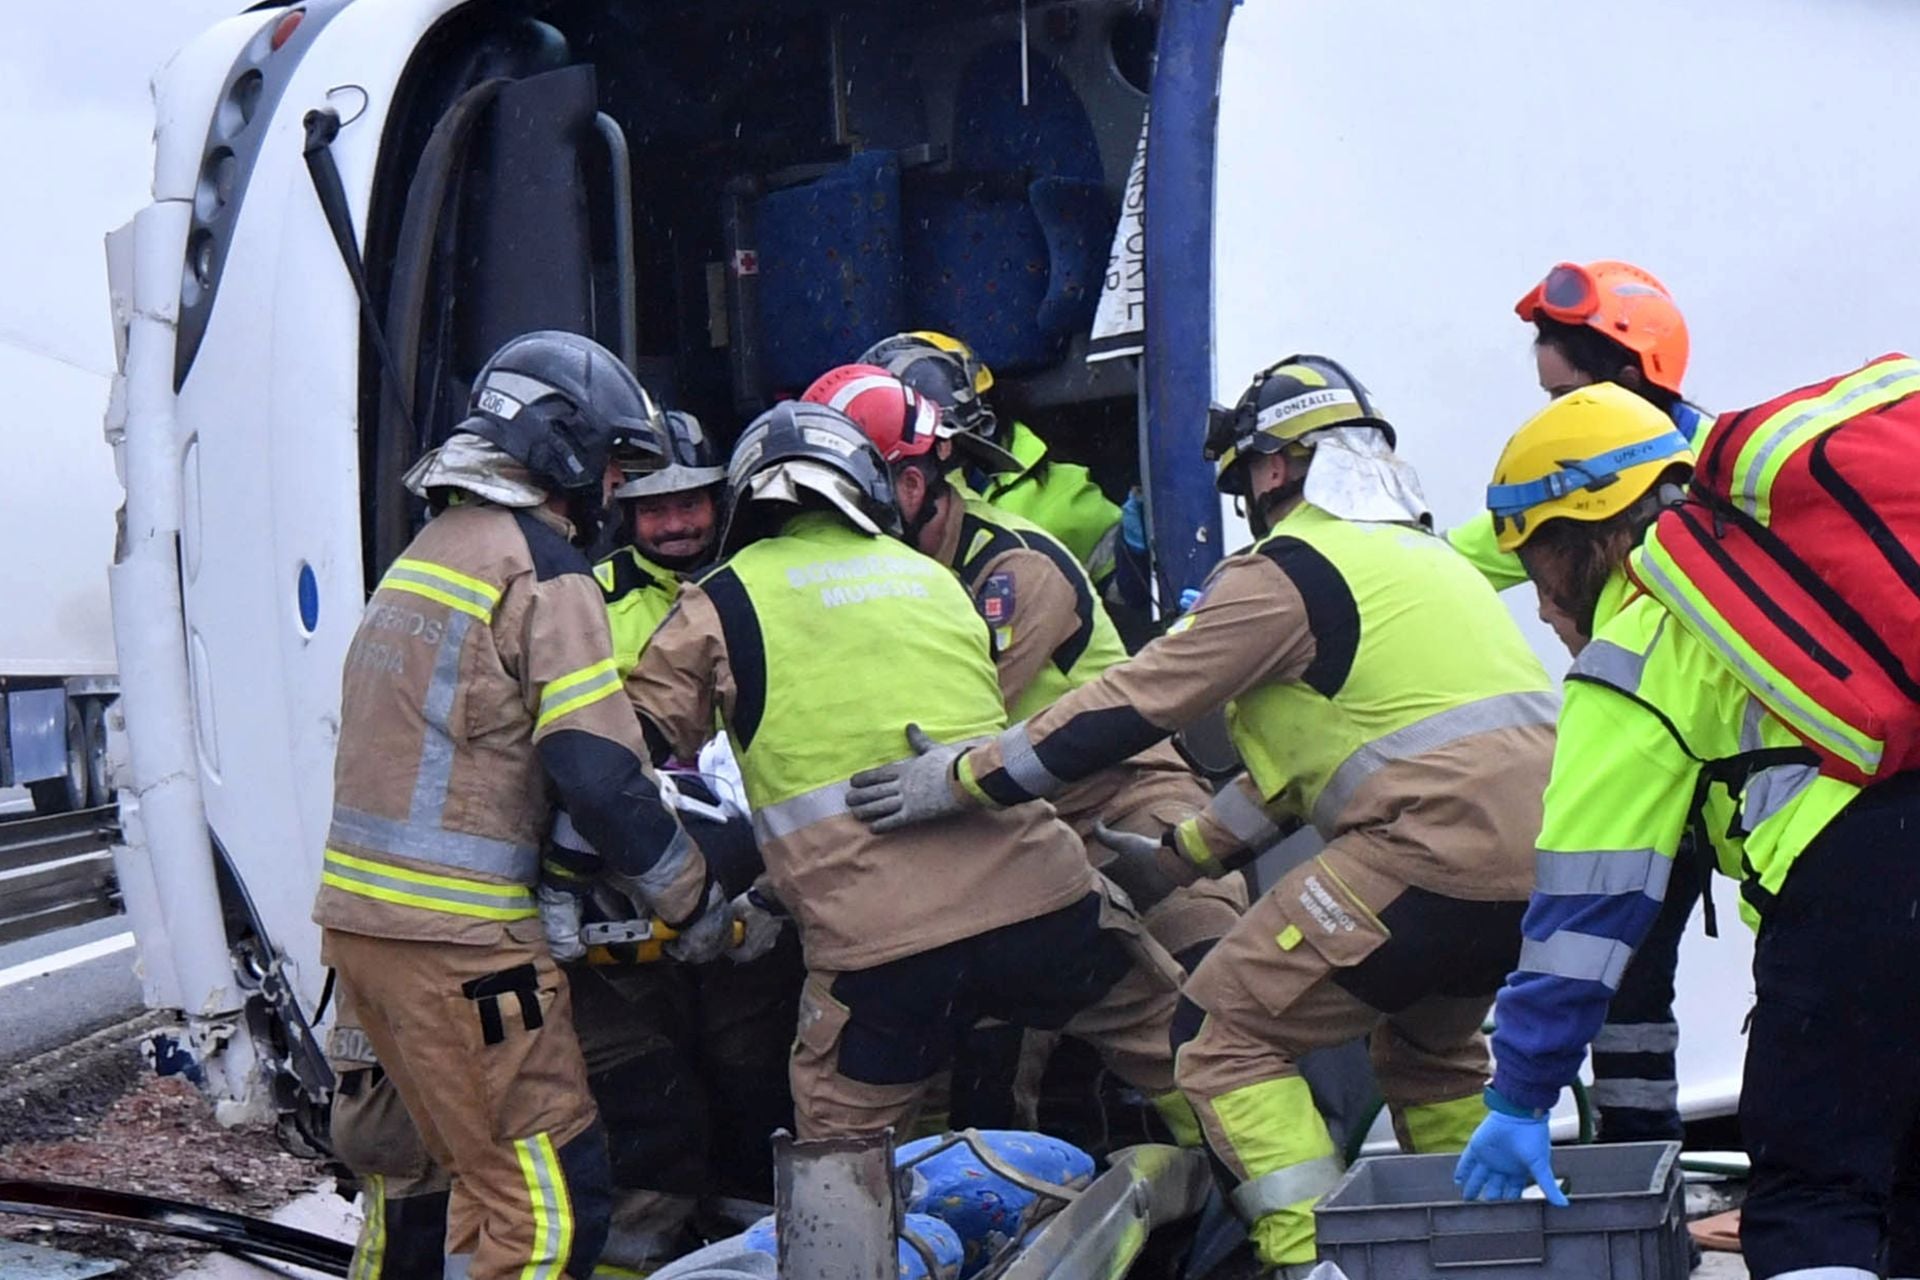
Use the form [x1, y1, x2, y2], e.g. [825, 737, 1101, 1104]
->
[1494, 572, 1859, 1107]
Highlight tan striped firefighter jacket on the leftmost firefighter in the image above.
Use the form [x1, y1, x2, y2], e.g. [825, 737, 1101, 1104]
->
[313, 503, 707, 942]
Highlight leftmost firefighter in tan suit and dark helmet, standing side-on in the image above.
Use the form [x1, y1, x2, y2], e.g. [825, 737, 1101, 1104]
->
[313, 330, 733, 1280]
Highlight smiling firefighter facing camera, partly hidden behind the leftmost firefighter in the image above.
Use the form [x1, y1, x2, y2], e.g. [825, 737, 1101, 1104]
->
[549, 409, 804, 1272]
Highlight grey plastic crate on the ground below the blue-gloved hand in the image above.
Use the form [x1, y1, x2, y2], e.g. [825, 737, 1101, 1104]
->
[1313, 1142, 1688, 1280]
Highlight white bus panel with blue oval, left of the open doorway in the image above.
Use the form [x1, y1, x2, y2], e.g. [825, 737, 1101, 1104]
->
[163, 0, 466, 1011]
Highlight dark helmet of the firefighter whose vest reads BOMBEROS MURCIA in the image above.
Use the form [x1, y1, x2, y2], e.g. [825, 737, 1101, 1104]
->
[720, 399, 900, 555]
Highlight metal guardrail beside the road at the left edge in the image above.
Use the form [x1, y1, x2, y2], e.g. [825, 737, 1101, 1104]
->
[0, 804, 121, 944]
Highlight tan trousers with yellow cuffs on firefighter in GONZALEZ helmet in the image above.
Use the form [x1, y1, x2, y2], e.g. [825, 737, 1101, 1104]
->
[1177, 844, 1524, 1265]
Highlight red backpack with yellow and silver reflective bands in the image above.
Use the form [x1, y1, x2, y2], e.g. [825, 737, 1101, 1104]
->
[1628, 355, 1920, 783]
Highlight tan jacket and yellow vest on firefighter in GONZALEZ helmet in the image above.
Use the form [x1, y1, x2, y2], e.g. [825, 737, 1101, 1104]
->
[960, 507, 1555, 900]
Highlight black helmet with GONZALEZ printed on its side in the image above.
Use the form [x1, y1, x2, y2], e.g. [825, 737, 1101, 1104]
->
[1206, 355, 1396, 495]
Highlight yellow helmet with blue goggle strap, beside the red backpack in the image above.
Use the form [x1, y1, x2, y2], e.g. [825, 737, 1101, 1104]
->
[1486, 382, 1693, 551]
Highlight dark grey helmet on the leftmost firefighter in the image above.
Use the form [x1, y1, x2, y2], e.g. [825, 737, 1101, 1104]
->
[453, 328, 662, 501]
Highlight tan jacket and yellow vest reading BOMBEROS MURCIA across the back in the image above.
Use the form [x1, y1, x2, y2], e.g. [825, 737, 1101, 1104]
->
[628, 512, 1092, 969]
